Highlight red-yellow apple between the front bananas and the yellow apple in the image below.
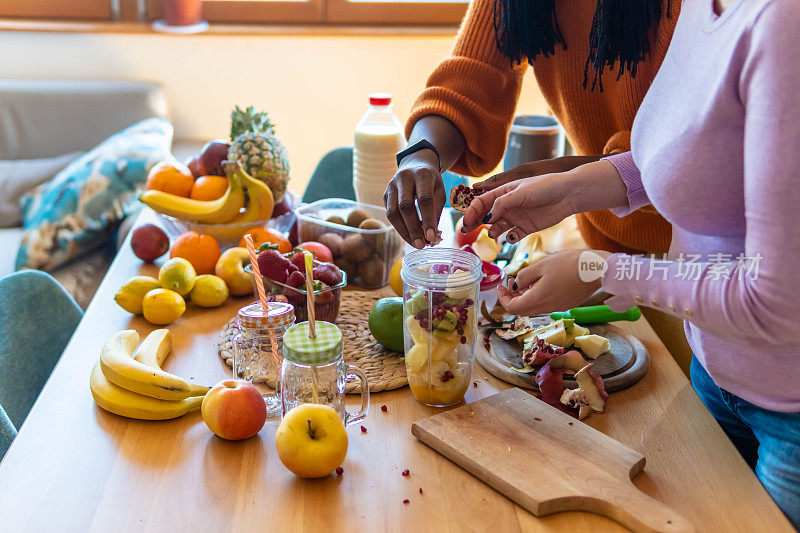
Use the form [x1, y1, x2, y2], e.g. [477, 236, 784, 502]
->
[200, 379, 267, 440]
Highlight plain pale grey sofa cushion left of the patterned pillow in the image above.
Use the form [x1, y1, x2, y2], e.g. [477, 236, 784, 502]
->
[0, 152, 83, 227]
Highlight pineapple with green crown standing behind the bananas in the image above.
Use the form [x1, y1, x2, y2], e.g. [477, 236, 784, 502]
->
[228, 106, 289, 203]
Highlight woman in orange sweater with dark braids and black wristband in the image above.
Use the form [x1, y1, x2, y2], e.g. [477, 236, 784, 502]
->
[384, 0, 680, 253]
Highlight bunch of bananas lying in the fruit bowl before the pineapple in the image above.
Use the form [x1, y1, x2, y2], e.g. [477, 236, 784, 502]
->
[139, 161, 275, 224]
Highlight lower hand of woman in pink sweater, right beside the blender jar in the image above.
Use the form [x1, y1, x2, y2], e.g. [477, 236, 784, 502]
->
[497, 250, 611, 316]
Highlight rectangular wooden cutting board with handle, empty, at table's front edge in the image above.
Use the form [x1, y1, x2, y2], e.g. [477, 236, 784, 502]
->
[411, 389, 694, 532]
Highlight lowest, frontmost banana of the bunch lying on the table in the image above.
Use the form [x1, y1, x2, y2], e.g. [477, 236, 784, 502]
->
[89, 362, 203, 420]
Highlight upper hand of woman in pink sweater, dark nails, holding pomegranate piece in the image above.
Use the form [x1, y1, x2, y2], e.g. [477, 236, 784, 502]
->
[464, 173, 578, 242]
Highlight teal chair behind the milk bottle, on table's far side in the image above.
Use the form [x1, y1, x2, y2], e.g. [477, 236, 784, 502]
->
[303, 146, 467, 204]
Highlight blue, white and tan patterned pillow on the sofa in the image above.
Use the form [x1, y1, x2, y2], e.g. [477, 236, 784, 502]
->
[15, 118, 172, 270]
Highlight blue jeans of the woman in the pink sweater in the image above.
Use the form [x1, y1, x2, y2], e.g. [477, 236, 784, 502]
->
[691, 357, 800, 530]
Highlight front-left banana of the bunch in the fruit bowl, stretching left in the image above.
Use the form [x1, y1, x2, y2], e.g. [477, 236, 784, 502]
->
[140, 168, 244, 224]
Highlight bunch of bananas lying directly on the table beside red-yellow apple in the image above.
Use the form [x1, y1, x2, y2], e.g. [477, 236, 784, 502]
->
[89, 329, 209, 420]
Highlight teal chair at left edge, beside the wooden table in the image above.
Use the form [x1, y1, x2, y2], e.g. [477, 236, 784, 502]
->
[0, 270, 83, 456]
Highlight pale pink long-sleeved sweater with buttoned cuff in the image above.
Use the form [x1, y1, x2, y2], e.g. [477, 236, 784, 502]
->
[603, 0, 800, 412]
